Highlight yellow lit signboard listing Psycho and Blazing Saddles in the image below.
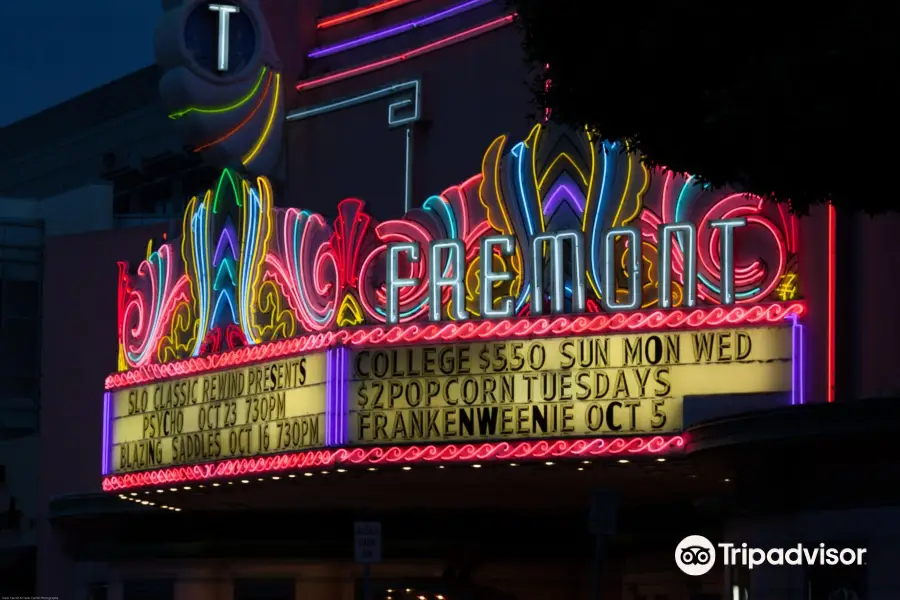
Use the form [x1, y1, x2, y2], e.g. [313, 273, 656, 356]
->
[110, 353, 326, 473]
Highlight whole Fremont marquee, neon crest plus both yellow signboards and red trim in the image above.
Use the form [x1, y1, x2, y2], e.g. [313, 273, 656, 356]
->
[103, 126, 806, 489]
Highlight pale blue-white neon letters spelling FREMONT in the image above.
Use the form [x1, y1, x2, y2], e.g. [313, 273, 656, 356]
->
[387, 218, 747, 324]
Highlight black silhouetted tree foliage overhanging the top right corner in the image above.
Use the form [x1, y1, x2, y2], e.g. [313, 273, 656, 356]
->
[508, 0, 900, 213]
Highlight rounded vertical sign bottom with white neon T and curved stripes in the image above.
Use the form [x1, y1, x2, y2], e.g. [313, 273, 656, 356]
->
[156, 0, 284, 174]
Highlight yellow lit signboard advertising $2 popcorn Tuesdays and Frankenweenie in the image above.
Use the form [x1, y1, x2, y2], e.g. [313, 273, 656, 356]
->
[349, 327, 792, 444]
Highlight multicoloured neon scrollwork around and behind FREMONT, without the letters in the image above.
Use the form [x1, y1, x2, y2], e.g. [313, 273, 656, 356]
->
[119, 125, 802, 370]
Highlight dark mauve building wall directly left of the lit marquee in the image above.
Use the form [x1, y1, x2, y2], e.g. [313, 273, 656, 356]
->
[37, 226, 164, 595]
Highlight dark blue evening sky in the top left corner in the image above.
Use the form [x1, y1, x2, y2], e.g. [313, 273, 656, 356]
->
[0, 0, 162, 127]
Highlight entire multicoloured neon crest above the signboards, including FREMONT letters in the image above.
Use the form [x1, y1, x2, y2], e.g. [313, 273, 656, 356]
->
[119, 126, 800, 371]
